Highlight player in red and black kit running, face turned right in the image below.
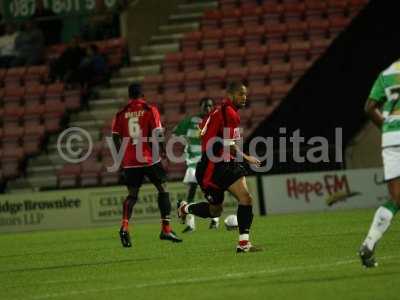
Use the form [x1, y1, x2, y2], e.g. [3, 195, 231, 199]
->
[178, 82, 261, 252]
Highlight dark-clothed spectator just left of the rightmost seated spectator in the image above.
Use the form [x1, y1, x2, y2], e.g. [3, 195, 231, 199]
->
[49, 37, 86, 82]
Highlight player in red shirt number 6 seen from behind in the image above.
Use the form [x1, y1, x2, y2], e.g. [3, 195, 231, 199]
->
[112, 83, 182, 247]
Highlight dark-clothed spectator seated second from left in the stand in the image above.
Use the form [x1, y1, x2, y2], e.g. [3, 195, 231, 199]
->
[11, 20, 45, 67]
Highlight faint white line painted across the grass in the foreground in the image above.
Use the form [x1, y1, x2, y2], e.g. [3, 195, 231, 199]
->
[32, 256, 400, 300]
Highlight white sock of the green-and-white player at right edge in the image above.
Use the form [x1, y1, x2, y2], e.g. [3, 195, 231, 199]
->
[363, 206, 393, 250]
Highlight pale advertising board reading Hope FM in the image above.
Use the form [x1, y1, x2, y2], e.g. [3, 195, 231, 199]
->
[262, 168, 389, 214]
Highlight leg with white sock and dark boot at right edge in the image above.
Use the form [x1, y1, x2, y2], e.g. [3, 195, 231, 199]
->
[360, 178, 400, 267]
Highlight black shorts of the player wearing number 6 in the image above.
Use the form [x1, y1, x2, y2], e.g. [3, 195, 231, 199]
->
[124, 162, 167, 188]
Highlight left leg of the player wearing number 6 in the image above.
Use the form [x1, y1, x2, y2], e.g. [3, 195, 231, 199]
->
[119, 168, 144, 247]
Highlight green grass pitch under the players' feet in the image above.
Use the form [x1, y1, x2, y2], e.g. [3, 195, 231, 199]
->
[0, 210, 400, 300]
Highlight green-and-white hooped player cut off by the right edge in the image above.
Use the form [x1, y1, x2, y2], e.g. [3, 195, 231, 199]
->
[359, 60, 400, 268]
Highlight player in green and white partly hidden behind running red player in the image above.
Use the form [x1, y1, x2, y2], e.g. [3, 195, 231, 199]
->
[173, 98, 219, 232]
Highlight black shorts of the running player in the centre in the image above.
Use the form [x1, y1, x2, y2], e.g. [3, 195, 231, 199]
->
[196, 154, 248, 204]
